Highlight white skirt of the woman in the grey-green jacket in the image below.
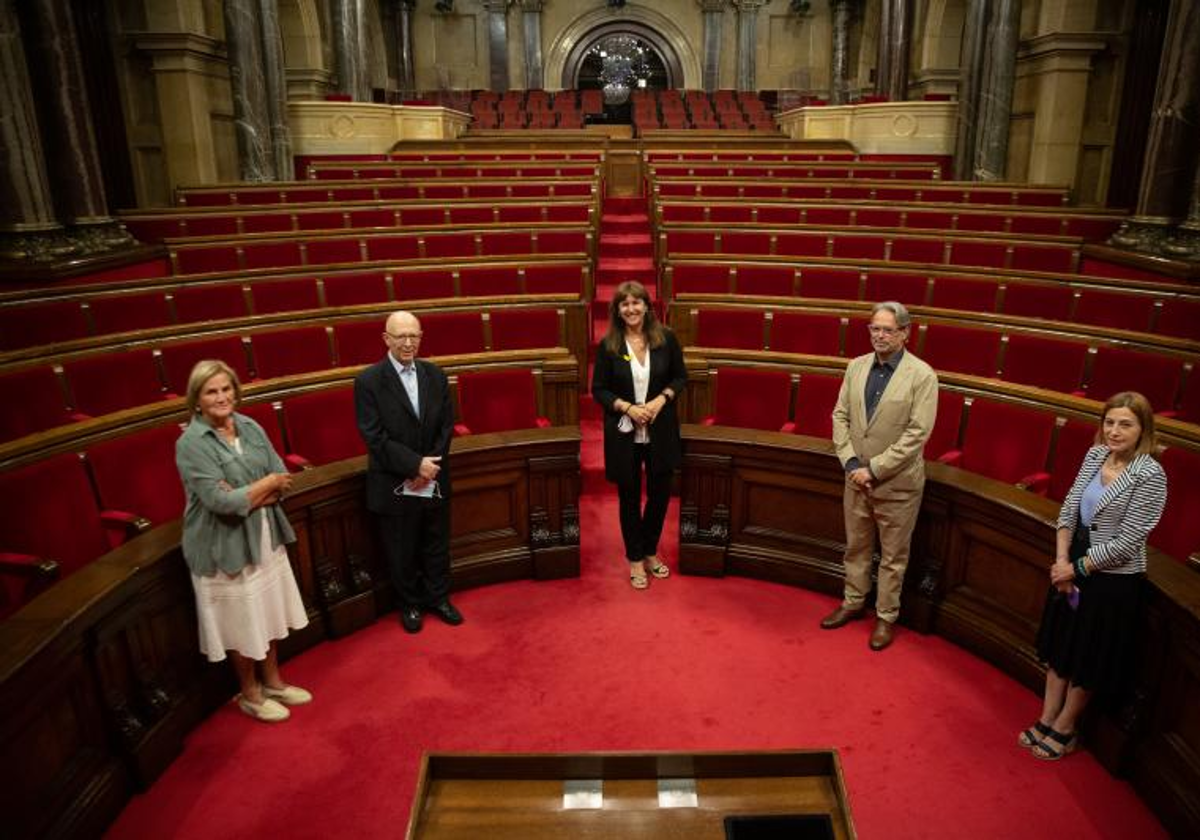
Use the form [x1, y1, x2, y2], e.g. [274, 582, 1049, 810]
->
[192, 516, 308, 662]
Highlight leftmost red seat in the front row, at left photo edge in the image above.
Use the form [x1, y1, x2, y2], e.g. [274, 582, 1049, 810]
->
[0, 452, 108, 578]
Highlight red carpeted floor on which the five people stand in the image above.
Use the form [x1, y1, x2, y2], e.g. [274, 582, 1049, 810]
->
[109, 421, 1165, 840]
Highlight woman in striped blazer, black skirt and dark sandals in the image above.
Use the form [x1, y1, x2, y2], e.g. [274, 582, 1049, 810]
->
[1018, 391, 1166, 761]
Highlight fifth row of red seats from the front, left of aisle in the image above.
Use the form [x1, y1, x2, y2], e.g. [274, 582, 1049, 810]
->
[121, 199, 596, 242]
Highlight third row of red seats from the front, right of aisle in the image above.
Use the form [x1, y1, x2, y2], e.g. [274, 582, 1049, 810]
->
[661, 262, 1200, 341]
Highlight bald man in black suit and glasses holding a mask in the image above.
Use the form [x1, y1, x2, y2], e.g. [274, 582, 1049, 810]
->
[354, 312, 462, 632]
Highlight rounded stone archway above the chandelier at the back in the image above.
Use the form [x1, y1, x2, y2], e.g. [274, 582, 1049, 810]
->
[546, 6, 703, 89]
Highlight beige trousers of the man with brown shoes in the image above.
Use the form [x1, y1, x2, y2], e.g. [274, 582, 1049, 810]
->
[842, 479, 922, 623]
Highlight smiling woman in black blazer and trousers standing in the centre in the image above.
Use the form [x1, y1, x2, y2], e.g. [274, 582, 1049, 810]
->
[592, 281, 688, 589]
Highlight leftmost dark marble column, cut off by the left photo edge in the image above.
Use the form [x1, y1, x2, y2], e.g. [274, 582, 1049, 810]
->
[0, 0, 61, 236]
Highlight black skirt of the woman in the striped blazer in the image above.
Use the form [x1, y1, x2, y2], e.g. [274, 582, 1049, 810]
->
[1038, 571, 1145, 697]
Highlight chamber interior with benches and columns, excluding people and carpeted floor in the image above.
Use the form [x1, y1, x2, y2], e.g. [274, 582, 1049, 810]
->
[0, 0, 1200, 838]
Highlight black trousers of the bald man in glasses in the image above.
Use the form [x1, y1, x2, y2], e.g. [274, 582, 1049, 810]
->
[379, 498, 450, 607]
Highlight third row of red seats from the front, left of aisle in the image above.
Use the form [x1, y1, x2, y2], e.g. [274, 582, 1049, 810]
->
[0, 262, 590, 350]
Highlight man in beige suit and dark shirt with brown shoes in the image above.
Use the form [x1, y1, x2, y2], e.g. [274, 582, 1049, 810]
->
[821, 301, 937, 650]
